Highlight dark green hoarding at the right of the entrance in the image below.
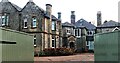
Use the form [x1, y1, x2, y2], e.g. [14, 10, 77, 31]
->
[94, 31, 120, 63]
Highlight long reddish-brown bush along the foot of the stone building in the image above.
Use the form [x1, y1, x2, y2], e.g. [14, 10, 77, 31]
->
[40, 48, 74, 56]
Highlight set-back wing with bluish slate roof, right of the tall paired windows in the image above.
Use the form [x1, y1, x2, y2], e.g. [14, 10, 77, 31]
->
[75, 19, 96, 50]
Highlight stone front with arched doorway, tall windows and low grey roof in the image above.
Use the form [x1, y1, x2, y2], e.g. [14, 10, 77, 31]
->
[62, 22, 87, 52]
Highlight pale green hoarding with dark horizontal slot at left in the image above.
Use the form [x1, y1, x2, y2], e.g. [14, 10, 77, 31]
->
[0, 28, 34, 62]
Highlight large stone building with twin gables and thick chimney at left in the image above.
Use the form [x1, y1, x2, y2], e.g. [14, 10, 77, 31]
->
[0, 0, 62, 53]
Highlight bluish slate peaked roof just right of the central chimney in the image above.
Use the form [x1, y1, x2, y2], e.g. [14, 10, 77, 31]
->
[75, 19, 96, 30]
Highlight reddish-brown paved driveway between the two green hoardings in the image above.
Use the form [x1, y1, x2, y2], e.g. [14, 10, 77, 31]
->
[34, 53, 94, 61]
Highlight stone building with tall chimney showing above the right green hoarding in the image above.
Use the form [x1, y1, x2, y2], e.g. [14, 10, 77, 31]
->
[96, 11, 120, 33]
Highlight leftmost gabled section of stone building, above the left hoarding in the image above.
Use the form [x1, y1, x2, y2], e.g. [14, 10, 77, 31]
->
[0, 0, 21, 31]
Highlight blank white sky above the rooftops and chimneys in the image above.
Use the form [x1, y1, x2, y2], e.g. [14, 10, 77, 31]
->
[0, 0, 120, 25]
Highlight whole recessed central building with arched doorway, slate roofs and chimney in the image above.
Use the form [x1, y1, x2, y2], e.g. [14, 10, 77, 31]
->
[62, 11, 96, 51]
